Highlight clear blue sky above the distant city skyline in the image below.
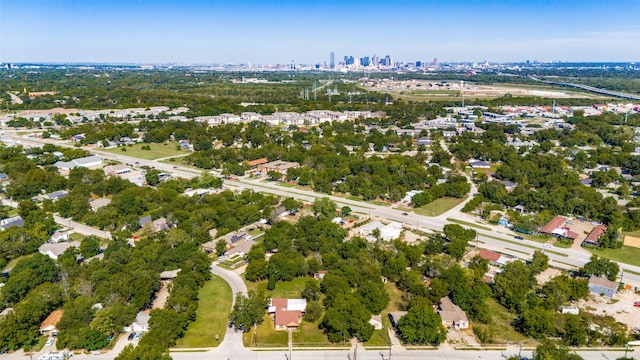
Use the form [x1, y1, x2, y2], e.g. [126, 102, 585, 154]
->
[0, 0, 640, 64]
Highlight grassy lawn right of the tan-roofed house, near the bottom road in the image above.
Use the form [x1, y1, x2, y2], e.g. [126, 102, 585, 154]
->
[473, 298, 535, 345]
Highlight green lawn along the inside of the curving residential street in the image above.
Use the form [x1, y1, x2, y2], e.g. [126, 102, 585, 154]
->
[176, 275, 232, 348]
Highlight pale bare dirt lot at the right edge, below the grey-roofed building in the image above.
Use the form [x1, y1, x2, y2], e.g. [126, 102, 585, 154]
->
[577, 291, 640, 330]
